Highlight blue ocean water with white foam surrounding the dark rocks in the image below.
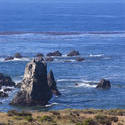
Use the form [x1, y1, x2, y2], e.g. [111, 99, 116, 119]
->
[0, 0, 125, 111]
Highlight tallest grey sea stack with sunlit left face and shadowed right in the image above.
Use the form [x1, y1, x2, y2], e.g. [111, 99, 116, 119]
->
[10, 59, 52, 105]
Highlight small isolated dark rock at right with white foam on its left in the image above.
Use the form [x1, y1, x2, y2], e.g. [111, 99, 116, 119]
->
[96, 79, 111, 89]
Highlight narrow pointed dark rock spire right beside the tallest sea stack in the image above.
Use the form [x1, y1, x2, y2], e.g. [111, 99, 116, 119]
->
[47, 70, 61, 96]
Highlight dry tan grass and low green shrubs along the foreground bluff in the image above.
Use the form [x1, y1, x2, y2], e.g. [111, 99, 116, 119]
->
[0, 109, 125, 125]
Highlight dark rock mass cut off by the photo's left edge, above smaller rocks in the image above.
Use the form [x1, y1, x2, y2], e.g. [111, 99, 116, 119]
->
[0, 73, 15, 86]
